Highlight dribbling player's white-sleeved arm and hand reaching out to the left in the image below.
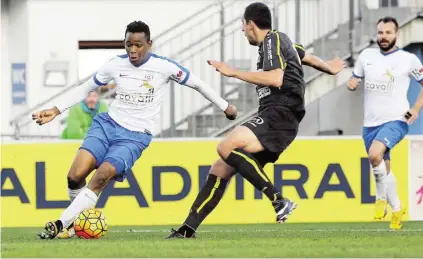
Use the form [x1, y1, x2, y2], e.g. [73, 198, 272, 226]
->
[32, 78, 99, 125]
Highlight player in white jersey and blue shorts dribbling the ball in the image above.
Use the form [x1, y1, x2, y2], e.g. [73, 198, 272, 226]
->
[33, 21, 236, 239]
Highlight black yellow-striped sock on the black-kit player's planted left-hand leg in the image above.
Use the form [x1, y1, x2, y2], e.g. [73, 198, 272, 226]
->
[178, 174, 228, 237]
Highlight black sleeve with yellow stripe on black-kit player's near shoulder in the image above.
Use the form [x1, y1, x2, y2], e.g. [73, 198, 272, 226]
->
[263, 32, 286, 71]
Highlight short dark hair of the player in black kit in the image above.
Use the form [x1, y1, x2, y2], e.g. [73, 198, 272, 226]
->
[244, 3, 272, 30]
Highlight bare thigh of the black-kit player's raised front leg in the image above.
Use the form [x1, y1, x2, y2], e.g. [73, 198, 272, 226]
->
[217, 126, 264, 158]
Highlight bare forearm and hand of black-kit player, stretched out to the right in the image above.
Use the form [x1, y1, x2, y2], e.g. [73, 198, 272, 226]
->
[301, 52, 346, 75]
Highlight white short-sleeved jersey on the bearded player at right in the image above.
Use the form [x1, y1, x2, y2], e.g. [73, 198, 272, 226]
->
[353, 48, 423, 127]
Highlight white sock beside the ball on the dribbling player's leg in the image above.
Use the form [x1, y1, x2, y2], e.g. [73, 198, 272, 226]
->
[60, 188, 98, 228]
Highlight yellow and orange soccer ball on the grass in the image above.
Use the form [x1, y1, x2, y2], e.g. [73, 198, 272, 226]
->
[73, 209, 107, 239]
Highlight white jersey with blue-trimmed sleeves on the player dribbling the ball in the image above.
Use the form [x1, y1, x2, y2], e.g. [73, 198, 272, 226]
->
[93, 53, 190, 132]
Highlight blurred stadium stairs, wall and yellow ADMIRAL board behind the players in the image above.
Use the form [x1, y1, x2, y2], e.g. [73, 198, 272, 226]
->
[1, 0, 423, 258]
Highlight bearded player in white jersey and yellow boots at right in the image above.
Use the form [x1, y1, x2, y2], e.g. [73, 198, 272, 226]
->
[348, 17, 423, 229]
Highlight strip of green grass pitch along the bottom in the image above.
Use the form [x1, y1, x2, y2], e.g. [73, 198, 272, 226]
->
[1, 222, 423, 258]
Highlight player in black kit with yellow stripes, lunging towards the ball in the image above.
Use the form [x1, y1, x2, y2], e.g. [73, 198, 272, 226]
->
[167, 3, 345, 238]
